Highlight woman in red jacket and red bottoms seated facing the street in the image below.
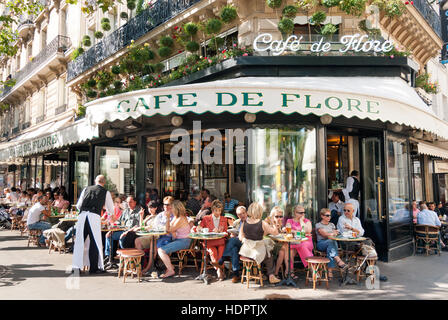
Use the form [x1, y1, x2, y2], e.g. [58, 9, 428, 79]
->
[200, 200, 228, 281]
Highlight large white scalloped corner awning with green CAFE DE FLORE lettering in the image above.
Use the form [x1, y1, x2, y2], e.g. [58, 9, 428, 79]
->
[86, 77, 448, 139]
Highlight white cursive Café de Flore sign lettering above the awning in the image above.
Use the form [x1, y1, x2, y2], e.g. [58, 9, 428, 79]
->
[253, 33, 394, 56]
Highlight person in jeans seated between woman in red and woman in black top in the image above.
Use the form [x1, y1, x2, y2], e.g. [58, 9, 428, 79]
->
[218, 206, 247, 283]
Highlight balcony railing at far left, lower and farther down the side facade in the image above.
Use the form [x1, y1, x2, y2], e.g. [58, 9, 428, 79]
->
[0, 35, 71, 99]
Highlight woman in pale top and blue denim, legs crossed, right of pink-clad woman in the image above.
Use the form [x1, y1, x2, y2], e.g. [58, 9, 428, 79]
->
[316, 208, 348, 279]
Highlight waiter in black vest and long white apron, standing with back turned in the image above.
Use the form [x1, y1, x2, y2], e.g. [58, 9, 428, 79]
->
[72, 175, 114, 274]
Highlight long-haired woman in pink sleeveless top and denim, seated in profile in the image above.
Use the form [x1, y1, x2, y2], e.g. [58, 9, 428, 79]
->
[157, 200, 191, 278]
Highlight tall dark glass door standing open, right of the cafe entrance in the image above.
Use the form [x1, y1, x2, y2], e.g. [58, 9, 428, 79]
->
[360, 137, 387, 260]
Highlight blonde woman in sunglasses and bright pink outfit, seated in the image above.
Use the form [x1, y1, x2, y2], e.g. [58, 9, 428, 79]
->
[285, 205, 313, 278]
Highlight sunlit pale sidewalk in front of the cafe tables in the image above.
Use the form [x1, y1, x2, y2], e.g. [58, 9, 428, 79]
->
[0, 230, 448, 300]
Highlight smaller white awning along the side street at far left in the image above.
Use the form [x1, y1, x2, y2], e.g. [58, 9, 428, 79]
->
[0, 117, 98, 162]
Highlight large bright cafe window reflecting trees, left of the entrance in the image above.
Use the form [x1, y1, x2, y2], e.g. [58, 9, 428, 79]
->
[248, 127, 317, 220]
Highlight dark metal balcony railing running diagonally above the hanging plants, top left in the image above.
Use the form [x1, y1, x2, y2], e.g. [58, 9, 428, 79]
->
[67, 0, 200, 81]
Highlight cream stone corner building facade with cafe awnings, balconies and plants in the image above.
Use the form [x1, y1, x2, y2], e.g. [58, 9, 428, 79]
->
[0, 0, 448, 261]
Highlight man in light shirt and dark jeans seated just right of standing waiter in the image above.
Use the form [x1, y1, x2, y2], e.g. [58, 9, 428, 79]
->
[104, 196, 143, 260]
